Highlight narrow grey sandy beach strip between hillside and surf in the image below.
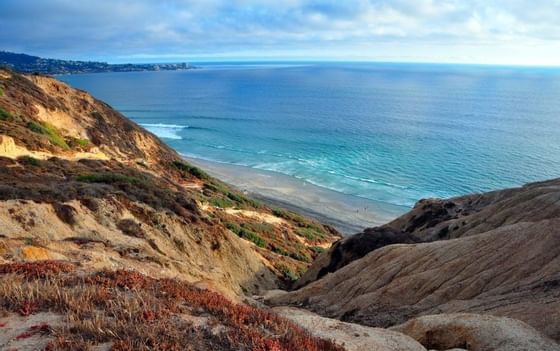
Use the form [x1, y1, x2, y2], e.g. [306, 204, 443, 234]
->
[181, 155, 407, 236]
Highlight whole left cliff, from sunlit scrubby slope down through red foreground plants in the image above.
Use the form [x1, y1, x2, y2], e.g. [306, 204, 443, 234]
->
[0, 70, 346, 350]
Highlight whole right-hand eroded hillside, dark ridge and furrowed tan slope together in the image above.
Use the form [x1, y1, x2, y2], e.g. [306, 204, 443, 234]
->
[269, 179, 560, 350]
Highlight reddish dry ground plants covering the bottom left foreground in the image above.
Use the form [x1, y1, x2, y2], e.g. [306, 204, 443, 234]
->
[0, 261, 342, 351]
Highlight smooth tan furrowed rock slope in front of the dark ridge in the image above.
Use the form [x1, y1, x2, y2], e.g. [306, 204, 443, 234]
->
[268, 219, 560, 340]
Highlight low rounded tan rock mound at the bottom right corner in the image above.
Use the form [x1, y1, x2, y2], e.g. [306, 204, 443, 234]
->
[391, 313, 560, 351]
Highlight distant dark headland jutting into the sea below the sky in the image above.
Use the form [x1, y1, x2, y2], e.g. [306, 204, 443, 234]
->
[0, 51, 195, 74]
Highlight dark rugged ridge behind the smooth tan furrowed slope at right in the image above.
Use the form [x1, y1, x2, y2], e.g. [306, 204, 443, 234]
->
[294, 180, 560, 289]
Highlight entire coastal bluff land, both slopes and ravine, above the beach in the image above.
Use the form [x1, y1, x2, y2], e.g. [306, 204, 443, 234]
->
[0, 69, 560, 351]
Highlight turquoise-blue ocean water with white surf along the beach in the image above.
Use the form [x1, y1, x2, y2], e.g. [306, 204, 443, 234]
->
[60, 63, 560, 211]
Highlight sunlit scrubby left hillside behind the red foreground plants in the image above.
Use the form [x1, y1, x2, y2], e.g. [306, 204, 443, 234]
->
[0, 70, 348, 349]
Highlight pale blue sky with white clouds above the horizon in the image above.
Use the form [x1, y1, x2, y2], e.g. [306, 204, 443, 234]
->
[0, 0, 560, 66]
